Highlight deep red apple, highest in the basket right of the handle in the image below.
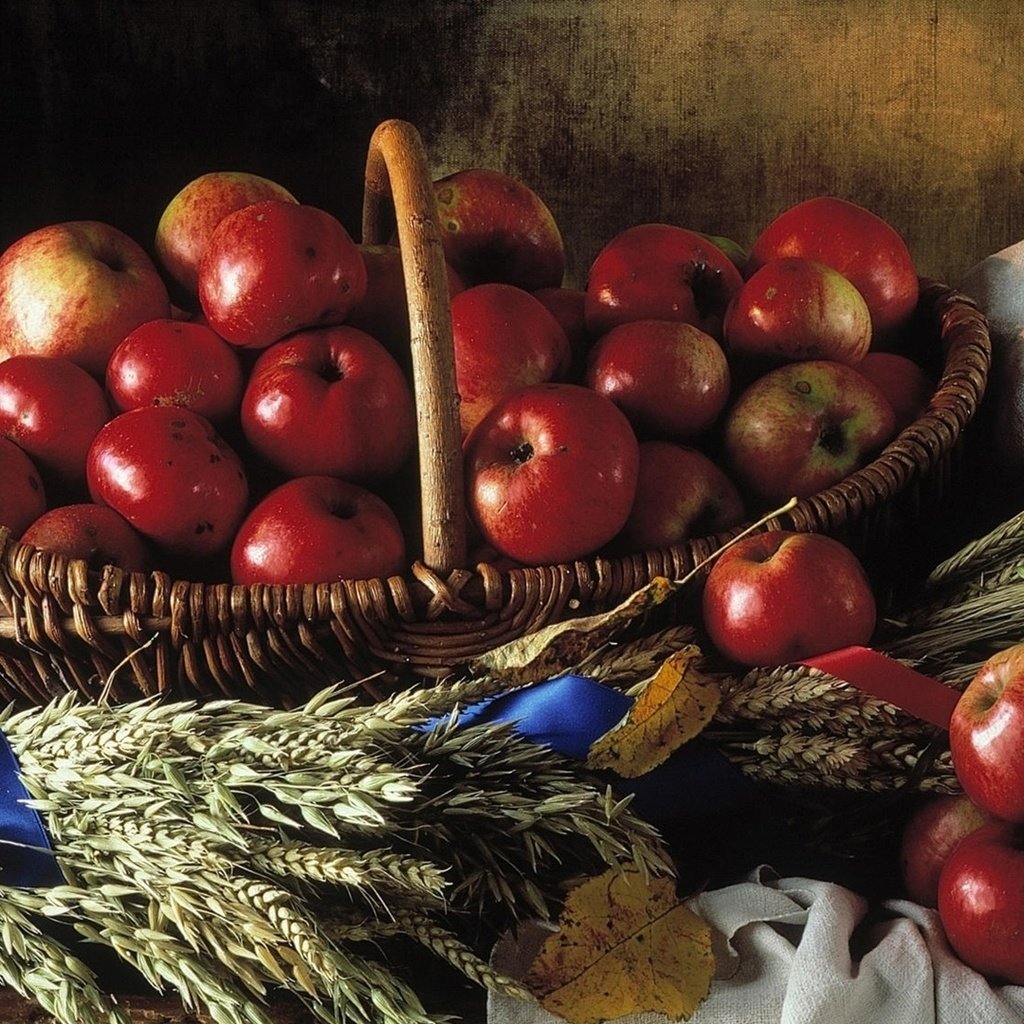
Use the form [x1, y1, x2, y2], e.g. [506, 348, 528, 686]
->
[746, 196, 920, 348]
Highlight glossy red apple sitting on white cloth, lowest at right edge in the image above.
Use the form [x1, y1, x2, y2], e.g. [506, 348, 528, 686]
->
[938, 821, 1024, 985]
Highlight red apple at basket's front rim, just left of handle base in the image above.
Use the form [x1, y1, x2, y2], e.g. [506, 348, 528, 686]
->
[230, 475, 406, 586]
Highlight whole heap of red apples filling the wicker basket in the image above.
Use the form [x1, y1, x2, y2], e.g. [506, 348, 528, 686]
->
[0, 162, 934, 584]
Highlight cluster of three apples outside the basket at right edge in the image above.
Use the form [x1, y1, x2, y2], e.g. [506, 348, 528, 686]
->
[900, 644, 1024, 985]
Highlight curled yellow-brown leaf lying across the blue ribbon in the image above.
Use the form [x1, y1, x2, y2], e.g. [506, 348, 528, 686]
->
[587, 644, 722, 778]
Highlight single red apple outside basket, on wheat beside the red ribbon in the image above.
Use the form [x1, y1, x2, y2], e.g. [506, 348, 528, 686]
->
[701, 529, 878, 667]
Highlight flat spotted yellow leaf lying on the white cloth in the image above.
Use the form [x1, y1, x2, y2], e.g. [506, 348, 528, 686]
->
[525, 870, 715, 1024]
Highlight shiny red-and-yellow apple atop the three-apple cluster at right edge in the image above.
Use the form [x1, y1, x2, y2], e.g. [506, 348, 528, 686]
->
[949, 644, 1024, 821]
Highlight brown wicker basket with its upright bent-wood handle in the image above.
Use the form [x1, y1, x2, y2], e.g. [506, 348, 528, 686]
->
[0, 119, 991, 706]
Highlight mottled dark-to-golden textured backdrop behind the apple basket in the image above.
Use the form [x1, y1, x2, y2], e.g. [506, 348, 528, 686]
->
[0, 0, 1024, 282]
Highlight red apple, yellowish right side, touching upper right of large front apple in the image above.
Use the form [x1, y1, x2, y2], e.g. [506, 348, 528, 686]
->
[584, 319, 732, 441]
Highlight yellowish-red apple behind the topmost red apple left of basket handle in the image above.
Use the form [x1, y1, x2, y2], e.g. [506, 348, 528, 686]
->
[154, 171, 298, 305]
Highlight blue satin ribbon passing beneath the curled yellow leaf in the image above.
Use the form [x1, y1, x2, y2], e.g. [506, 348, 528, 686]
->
[423, 674, 757, 830]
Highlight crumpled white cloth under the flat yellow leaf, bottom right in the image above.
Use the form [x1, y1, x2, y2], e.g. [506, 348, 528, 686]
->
[487, 867, 1024, 1024]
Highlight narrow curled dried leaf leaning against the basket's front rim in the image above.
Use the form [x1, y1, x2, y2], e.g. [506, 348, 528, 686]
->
[470, 577, 677, 686]
